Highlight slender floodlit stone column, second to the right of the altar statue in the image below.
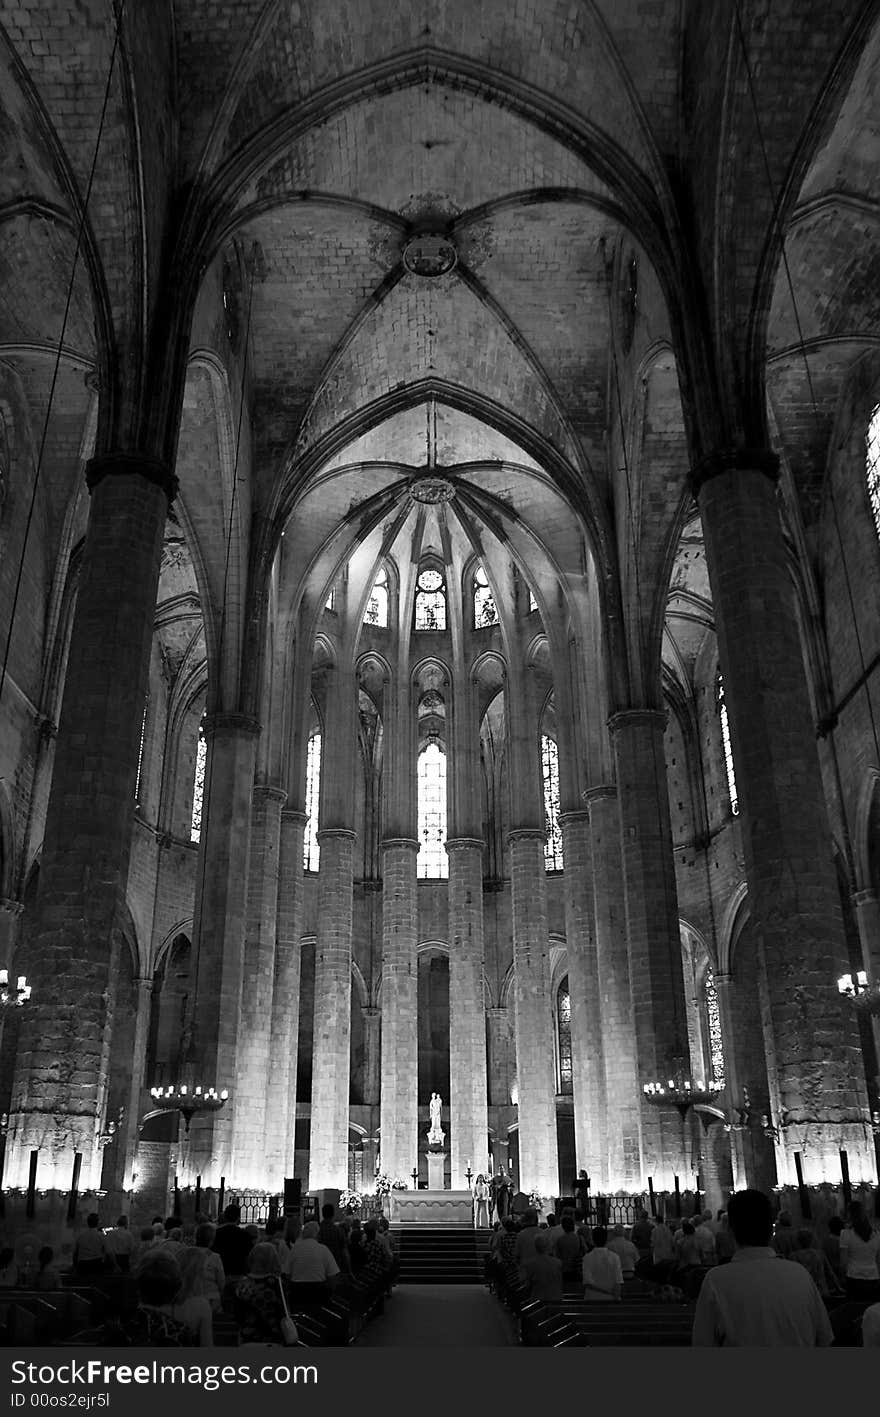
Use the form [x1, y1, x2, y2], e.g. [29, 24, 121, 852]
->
[507, 828, 560, 1196]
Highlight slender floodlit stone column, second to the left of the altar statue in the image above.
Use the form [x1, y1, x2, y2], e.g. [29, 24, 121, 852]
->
[309, 828, 356, 1190]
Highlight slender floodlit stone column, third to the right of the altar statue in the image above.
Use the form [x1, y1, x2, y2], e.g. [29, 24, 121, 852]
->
[560, 811, 608, 1189]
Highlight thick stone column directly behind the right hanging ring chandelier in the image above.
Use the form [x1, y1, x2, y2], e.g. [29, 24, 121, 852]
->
[608, 709, 689, 1187]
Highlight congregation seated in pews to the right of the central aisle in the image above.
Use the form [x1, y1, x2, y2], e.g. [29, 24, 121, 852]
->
[486, 1190, 880, 1346]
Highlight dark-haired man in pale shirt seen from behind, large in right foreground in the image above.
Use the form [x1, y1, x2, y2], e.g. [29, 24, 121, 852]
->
[692, 1190, 833, 1348]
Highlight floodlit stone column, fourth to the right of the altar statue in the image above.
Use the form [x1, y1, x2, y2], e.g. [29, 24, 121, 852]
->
[584, 785, 648, 1190]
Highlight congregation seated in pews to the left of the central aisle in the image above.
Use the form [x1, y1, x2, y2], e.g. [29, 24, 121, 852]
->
[0, 1204, 398, 1348]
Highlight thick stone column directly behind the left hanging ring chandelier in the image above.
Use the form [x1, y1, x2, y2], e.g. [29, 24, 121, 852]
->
[188, 713, 259, 1187]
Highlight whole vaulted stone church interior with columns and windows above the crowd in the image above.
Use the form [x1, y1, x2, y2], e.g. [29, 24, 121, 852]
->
[0, 0, 880, 1206]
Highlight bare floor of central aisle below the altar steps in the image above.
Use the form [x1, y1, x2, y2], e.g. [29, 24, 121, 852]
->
[356, 1284, 517, 1348]
